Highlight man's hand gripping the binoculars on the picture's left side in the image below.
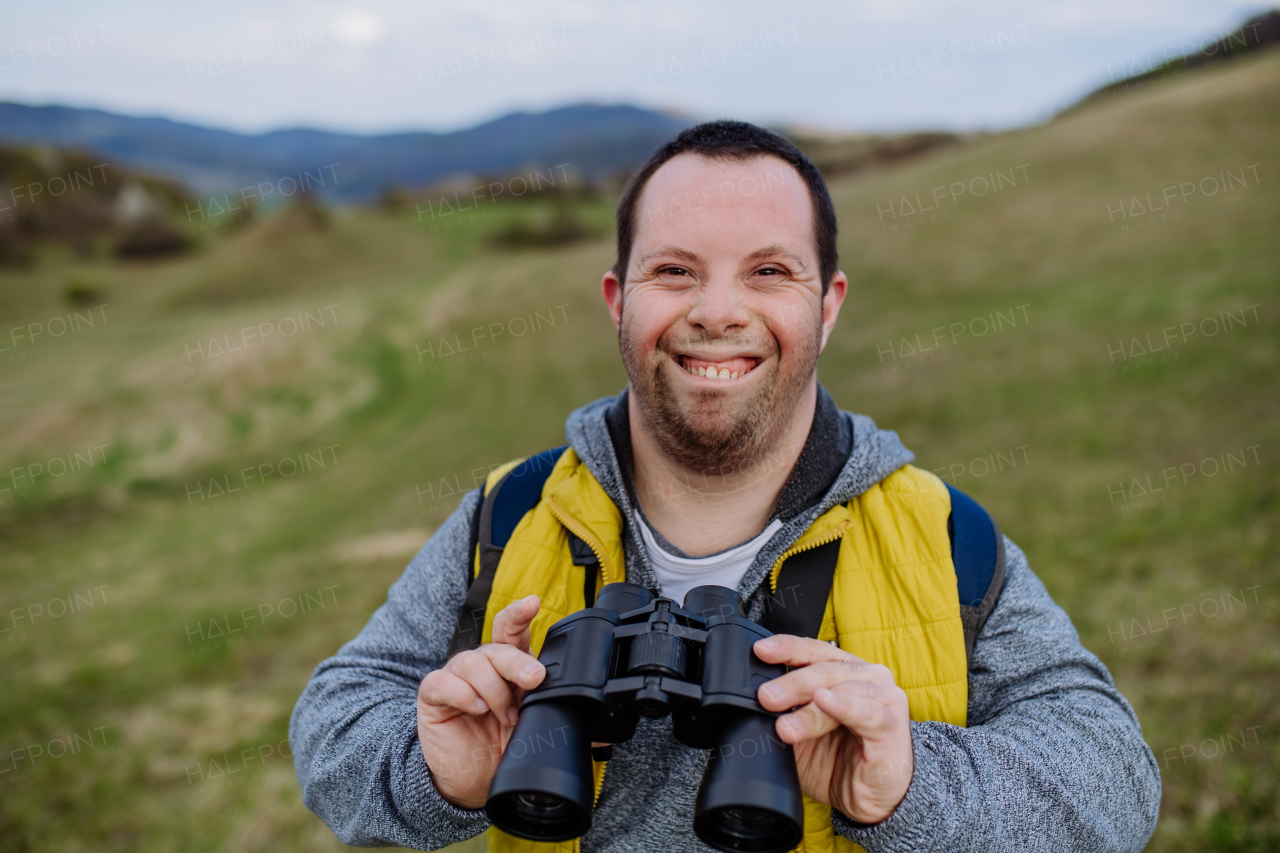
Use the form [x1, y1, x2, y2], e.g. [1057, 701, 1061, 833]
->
[417, 596, 547, 808]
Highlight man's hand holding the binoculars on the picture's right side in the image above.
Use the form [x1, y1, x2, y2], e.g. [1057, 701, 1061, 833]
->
[755, 634, 915, 824]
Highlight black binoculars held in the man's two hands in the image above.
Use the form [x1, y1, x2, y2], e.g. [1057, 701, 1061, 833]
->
[485, 583, 804, 853]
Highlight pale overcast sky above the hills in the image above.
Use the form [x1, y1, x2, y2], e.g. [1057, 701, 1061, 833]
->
[0, 0, 1265, 133]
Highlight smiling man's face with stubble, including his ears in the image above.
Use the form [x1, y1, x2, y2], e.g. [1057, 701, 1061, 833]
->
[603, 154, 847, 471]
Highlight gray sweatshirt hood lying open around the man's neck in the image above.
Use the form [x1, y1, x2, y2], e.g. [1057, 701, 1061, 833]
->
[564, 386, 915, 601]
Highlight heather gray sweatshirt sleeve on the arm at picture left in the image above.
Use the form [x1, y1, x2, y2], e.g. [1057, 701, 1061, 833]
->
[289, 489, 489, 850]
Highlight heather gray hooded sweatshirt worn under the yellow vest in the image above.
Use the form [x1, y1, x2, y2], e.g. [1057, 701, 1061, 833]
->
[289, 388, 1160, 853]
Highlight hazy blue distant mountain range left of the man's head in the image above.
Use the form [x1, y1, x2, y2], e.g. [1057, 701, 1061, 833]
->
[0, 102, 691, 201]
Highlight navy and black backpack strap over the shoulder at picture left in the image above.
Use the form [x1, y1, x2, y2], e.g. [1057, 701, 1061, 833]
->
[448, 444, 568, 657]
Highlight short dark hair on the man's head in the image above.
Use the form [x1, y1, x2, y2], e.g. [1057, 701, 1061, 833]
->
[613, 119, 838, 296]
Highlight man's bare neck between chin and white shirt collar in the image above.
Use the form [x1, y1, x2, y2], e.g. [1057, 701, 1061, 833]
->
[628, 382, 817, 556]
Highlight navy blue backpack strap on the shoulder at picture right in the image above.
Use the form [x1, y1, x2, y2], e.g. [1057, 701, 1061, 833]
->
[946, 483, 1005, 665]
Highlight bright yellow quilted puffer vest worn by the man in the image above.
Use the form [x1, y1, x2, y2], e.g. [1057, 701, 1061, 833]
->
[472, 447, 969, 853]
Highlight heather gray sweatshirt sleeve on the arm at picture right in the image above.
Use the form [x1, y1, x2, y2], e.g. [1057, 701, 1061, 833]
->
[832, 538, 1160, 853]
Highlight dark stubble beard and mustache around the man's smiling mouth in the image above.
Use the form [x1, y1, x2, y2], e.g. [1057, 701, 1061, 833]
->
[618, 311, 822, 475]
